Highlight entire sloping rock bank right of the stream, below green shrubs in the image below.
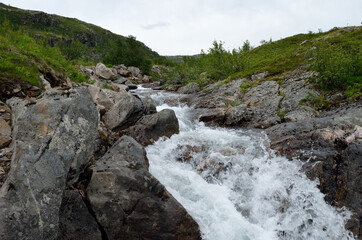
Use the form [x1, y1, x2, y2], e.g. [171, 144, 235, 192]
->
[163, 70, 362, 236]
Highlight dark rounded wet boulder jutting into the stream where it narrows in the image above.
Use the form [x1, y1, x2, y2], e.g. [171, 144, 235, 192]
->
[122, 109, 179, 146]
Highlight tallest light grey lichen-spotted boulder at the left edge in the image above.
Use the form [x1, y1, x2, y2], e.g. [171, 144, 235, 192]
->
[0, 87, 98, 240]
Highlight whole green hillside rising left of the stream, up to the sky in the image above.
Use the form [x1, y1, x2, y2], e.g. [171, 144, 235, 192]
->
[0, 3, 159, 85]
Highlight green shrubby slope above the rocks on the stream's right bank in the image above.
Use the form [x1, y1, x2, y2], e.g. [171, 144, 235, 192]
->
[160, 27, 362, 97]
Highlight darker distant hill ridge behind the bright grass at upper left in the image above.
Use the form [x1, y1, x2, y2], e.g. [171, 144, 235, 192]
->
[0, 3, 159, 61]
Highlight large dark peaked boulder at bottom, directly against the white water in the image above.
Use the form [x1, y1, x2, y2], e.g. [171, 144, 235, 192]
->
[87, 136, 201, 240]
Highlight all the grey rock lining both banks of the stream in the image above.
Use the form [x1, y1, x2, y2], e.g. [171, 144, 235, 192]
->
[0, 64, 362, 239]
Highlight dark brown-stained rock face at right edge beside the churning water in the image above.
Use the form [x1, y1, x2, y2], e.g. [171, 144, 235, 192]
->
[266, 104, 362, 235]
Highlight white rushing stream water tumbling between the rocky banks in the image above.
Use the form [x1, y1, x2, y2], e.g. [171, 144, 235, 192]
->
[140, 89, 354, 240]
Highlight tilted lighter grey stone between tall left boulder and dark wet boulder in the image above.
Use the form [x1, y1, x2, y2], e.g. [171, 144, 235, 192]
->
[102, 91, 135, 129]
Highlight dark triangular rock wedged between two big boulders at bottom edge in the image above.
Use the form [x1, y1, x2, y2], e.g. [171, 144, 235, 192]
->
[57, 190, 102, 240]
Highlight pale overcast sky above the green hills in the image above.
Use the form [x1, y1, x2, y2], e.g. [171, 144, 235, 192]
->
[0, 0, 362, 55]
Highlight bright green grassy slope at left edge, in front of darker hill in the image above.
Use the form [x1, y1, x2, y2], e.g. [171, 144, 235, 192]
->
[0, 22, 87, 86]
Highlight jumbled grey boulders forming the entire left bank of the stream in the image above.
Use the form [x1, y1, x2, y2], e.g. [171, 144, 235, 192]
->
[0, 64, 201, 240]
